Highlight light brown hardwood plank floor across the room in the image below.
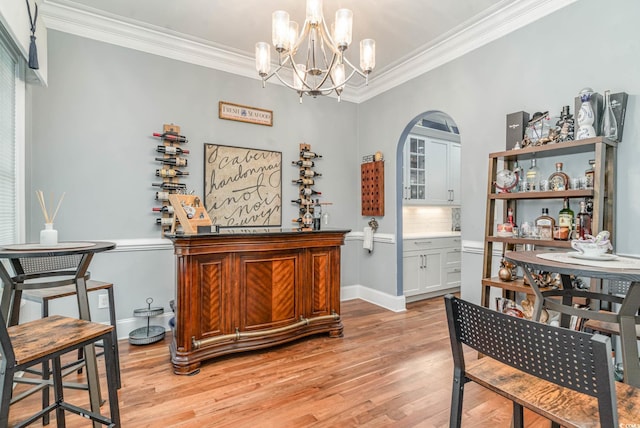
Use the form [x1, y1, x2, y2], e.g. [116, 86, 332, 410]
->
[10, 298, 549, 428]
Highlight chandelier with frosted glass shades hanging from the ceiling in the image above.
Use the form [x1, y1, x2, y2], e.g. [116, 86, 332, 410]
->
[256, 0, 376, 103]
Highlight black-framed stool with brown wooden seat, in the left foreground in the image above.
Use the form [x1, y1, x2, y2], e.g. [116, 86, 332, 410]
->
[0, 315, 120, 427]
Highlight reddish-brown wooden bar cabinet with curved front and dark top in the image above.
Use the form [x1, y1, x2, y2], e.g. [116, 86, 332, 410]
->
[162, 228, 349, 375]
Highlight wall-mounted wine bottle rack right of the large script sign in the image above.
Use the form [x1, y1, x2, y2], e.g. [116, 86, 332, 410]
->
[291, 143, 322, 231]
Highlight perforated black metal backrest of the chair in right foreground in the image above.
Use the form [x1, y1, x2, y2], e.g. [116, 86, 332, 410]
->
[445, 295, 618, 426]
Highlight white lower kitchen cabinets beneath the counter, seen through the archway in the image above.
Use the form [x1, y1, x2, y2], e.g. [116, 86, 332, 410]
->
[402, 237, 461, 297]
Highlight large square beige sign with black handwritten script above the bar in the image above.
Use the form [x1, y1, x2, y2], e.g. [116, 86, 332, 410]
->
[204, 144, 282, 227]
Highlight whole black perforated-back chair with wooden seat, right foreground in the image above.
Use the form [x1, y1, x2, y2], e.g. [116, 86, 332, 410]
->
[445, 295, 624, 428]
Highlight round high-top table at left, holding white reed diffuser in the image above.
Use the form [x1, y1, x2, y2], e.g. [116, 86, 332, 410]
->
[0, 241, 116, 427]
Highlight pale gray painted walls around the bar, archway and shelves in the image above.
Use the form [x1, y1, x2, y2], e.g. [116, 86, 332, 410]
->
[27, 0, 640, 335]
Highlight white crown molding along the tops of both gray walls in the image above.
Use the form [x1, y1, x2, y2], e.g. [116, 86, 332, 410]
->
[41, 0, 578, 103]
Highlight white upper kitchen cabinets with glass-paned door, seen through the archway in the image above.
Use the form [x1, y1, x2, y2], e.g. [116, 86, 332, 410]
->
[403, 135, 460, 205]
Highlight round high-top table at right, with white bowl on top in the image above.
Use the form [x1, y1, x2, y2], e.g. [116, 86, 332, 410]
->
[504, 251, 640, 387]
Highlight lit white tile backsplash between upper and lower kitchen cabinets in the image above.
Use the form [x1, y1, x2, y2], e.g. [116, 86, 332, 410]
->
[402, 206, 460, 233]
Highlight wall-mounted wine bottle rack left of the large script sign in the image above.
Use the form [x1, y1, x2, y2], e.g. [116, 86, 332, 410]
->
[153, 124, 189, 236]
